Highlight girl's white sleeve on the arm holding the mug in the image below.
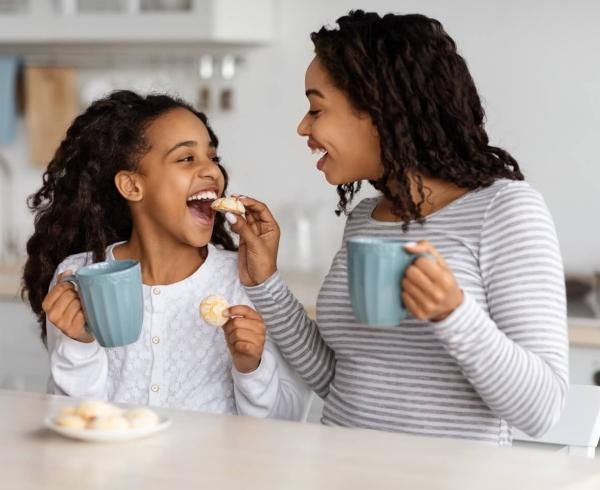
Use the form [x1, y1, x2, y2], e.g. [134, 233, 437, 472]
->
[46, 264, 108, 400]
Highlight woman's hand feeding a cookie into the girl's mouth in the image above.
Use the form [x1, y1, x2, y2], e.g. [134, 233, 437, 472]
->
[225, 197, 280, 286]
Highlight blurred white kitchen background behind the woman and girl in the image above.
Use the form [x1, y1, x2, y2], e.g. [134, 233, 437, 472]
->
[0, 0, 600, 396]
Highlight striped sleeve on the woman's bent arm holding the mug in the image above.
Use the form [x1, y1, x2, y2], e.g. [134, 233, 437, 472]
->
[434, 183, 569, 437]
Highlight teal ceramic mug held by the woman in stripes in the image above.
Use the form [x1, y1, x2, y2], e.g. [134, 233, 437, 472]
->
[347, 237, 429, 327]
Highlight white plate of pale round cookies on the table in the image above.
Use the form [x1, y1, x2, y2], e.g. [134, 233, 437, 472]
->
[44, 400, 171, 442]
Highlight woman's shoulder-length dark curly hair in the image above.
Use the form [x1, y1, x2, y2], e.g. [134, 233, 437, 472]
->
[311, 10, 524, 220]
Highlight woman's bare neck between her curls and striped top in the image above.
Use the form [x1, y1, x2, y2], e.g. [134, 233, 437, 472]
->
[373, 177, 469, 221]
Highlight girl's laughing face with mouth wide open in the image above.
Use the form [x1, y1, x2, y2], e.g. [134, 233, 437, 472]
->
[124, 109, 224, 247]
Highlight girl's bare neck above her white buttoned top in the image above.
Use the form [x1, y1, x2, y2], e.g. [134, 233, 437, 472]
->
[113, 227, 208, 286]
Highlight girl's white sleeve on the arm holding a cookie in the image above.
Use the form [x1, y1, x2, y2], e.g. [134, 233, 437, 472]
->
[232, 283, 311, 420]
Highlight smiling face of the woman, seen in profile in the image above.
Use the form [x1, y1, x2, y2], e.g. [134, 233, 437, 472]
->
[298, 58, 383, 185]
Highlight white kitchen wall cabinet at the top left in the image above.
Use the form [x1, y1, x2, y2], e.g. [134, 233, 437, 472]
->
[0, 0, 275, 44]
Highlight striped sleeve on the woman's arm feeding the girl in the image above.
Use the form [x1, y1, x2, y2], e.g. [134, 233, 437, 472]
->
[246, 272, 335, 398]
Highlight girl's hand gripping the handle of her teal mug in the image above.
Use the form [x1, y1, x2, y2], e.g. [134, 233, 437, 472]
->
[42, 271, 94, 343]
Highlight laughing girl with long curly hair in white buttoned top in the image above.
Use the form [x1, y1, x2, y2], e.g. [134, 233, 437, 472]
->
[24, 91, 305, 419]
